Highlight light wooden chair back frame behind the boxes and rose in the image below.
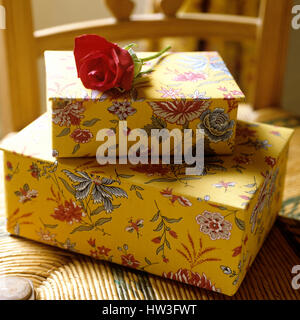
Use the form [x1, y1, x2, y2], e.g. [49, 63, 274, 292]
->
[0, 0, 292, 133]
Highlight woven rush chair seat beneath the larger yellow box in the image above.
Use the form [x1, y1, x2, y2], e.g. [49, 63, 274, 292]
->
[0, 108, 300, 300]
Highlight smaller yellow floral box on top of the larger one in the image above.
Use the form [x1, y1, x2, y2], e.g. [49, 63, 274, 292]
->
[45, 51, 244, 158]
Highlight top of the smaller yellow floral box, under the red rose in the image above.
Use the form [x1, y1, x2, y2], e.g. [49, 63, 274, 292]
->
[45, 51, 245, 101]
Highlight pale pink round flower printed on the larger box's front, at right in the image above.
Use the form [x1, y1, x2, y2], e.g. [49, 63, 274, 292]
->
[196, 211, 232, 240]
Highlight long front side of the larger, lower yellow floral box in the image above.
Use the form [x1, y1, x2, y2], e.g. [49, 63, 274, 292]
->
[2, 153, 244, 295]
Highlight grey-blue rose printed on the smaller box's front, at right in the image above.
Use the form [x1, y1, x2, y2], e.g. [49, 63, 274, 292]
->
[198, 108, 235, 142]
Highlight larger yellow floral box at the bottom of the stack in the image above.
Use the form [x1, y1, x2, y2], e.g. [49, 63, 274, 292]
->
[1, 114, 293, 295]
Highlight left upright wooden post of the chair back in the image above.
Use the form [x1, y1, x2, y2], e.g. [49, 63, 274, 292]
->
[0, 0, 40, 131]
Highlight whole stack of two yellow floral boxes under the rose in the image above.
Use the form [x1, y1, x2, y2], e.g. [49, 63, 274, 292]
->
[2, 38, 292, 295]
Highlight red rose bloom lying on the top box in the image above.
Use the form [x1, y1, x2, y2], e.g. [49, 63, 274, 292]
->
[74, 34, 134, 91]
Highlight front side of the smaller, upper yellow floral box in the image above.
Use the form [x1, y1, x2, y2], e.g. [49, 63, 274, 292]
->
[52, 97, 238, 157]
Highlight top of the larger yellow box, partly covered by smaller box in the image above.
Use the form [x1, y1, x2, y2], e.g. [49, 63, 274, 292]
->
[0, 113, 293, 209]
